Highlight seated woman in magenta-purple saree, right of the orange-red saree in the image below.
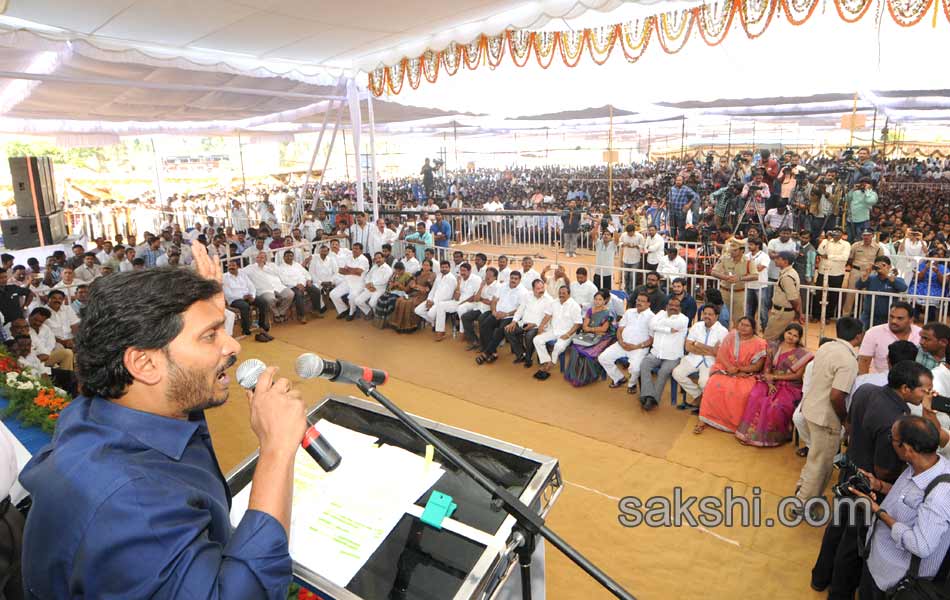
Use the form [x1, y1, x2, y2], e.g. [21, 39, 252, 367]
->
[736, 323, 814, 448]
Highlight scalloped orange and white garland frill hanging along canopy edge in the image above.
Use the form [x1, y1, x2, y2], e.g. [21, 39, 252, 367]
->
[369, 0, 950, 96]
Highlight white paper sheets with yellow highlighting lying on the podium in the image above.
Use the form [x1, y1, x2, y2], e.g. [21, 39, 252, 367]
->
[231, 419, 444, 587]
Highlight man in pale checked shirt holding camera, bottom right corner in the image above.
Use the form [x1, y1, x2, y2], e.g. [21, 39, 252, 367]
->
[854, 416, 950, 600]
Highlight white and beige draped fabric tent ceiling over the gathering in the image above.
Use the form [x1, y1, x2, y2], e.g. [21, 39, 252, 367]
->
[0, 0, 950, 135]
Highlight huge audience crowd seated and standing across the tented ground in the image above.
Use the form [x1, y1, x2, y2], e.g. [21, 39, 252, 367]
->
[9, 149, 950, 598]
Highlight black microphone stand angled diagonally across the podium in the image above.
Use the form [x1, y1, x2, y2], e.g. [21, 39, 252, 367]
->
[356, 380, 636, 600]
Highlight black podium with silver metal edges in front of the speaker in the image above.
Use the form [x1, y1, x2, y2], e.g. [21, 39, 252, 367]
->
[227, 396, 563, 600]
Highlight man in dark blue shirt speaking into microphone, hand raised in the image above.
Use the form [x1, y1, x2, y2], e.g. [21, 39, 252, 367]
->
[20, 244, 307, 600]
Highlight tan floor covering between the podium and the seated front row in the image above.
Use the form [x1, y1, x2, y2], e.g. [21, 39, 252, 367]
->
[208, 310, 822, 600]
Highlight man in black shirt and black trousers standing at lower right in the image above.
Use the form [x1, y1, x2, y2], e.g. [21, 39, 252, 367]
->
[811, 360, 933, 600]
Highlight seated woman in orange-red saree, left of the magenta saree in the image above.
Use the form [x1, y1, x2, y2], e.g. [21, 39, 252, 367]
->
[693, 317, 767, 433]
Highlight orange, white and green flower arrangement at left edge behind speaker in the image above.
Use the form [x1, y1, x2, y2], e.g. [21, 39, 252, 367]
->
[0, 353, 72, 433]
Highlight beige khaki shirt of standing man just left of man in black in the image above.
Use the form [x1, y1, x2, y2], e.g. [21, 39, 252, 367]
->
[802, 339, 858, 429]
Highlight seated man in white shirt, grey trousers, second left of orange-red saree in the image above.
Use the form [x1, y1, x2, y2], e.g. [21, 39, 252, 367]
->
[640, 296, 689, 411]
